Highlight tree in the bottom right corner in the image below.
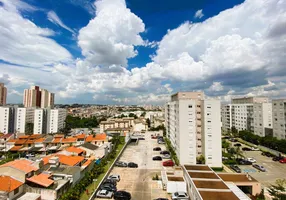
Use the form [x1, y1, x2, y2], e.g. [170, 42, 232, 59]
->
[268, 179, 286, 200]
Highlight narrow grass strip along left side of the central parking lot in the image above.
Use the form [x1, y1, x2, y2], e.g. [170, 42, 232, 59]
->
[80, 144, 125, 200]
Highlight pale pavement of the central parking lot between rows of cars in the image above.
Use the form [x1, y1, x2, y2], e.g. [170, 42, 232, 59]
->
[94, 132, 168, 200]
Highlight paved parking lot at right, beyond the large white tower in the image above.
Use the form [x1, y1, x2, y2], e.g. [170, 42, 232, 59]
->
[229, 141, 286, 187]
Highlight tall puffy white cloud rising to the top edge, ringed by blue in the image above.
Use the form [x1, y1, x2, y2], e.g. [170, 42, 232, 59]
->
[78, 0, 145, 67]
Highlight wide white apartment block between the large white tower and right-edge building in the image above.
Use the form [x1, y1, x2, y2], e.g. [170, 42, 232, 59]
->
[221, 97, 273, 137]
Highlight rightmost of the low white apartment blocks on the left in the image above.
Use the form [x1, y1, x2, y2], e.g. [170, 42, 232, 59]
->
[47, 109, 67, 133]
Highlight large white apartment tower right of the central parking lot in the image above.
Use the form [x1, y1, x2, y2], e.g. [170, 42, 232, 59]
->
[165, 92, 222, 167]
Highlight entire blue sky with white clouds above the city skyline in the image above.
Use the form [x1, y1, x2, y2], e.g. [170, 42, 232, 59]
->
[0, 0, 286, 105]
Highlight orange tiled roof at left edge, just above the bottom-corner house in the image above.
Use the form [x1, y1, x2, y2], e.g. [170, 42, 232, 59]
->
[0, 159, 39, 174]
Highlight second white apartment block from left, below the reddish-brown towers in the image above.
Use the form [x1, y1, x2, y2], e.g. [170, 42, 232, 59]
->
[15, 108, 35, 133]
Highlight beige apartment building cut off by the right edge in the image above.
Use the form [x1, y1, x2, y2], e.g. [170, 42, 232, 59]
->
[272, 99, 286, 139]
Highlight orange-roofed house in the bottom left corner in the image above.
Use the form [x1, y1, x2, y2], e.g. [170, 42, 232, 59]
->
[0, 175, 24, 200]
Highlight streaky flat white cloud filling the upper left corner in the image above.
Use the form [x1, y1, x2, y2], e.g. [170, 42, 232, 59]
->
[0, 0, 72, 67]
